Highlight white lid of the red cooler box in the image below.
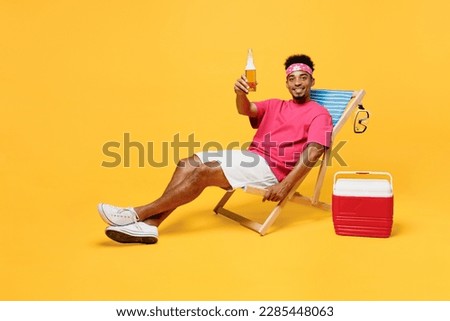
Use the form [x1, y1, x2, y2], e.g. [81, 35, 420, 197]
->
[333, 178, 392, 197]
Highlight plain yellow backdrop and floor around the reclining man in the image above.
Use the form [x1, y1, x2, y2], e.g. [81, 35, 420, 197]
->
[0, 0, 450, 300]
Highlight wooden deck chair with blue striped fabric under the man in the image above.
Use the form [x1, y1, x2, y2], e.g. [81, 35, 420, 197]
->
[214, 89, 365, 235]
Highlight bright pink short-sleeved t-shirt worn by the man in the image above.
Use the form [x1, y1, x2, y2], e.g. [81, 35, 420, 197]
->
[248, 99, 333, 182]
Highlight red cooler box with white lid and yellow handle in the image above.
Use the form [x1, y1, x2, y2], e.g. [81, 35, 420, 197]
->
[332, 171, 394, 237]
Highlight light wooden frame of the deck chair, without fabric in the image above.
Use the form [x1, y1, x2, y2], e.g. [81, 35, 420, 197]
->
[214, 90, 365, 235]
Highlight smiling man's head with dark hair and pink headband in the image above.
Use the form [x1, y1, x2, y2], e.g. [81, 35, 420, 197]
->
[284, 55, 315, 102]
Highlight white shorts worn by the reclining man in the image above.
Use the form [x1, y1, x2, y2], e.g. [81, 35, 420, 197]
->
[195, 149, 278, 189]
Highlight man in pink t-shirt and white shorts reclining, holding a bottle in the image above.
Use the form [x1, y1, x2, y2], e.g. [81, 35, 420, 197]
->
[98, 55, 333, 244]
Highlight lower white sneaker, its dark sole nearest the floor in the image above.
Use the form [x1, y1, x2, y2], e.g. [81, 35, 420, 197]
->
[105, 222, 158, 244]
